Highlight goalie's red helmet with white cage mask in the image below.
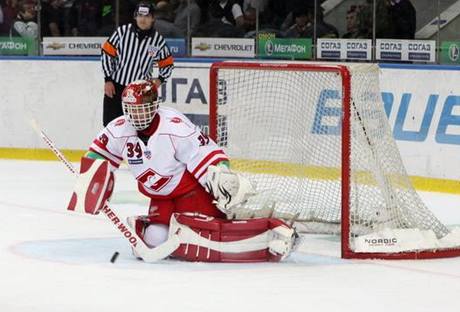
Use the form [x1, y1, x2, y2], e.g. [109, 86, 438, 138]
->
[121, 80, 158, 131]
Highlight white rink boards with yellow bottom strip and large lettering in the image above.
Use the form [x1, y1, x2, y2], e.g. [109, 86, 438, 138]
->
[0, 59, 460, 193]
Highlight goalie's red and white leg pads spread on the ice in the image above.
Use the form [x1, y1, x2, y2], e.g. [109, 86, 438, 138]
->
[128, 213, 296, 262]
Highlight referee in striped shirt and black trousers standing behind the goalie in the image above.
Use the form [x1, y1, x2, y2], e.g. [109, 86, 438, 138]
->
[102, 1, 174, 127]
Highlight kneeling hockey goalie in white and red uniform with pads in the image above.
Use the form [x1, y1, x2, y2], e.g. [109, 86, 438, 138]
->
[68, 80, 296, 262]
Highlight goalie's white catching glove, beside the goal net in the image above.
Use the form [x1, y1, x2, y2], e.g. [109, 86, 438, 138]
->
[206, 166, 256, 216]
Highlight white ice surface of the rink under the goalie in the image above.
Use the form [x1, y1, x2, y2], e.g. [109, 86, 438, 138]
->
[0, 160, 460, 312]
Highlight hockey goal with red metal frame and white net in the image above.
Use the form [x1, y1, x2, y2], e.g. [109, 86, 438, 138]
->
[209, 62, 460, 259]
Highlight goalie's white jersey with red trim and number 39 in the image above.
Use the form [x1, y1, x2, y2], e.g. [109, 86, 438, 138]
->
[90, 107, 228, 198]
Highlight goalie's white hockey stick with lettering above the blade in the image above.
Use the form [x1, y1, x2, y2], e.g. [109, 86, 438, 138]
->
[30, 118, 180, 262]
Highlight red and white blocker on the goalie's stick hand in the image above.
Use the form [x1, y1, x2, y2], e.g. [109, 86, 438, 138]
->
[67, 157, 114, 214]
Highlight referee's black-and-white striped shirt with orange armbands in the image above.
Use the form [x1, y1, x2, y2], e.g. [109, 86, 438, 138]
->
[102, 24, 174, 86]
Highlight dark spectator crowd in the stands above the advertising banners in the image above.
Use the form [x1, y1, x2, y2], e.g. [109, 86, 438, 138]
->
[0, 0, 416, 39]
